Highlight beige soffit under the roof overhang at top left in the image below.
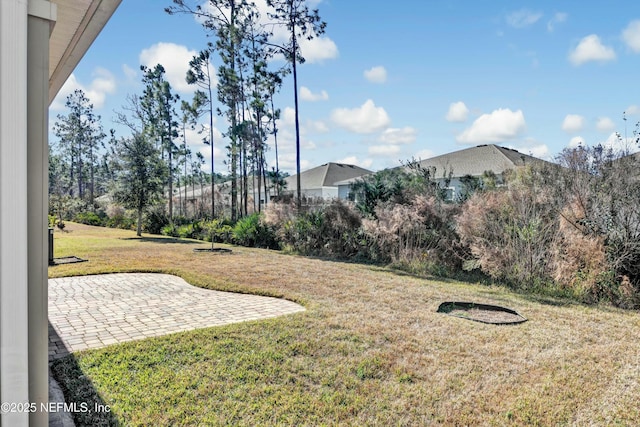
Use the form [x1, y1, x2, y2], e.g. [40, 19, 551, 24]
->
[49, 0, 122, 103]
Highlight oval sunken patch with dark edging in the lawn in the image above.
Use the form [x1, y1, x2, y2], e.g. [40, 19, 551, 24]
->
[438, 301, 527, 325]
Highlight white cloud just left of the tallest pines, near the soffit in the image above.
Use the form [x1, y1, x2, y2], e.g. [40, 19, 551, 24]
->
[140, 42, 215, 93]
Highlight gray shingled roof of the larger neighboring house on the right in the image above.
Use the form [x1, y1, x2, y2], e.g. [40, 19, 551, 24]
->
[419, 144, 543, 178]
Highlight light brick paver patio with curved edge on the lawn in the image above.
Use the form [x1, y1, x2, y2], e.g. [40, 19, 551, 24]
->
[49, 273, 304, 360]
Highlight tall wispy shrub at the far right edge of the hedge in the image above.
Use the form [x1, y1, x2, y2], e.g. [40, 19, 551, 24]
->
[551, 146, 640, 308]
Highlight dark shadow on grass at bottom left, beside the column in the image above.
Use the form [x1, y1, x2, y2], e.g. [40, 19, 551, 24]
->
[49, 323, 122, 427]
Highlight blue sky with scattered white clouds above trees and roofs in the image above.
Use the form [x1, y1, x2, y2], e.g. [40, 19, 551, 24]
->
[50, 0, 640, 176]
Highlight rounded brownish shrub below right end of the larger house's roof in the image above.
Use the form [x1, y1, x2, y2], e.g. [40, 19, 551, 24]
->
[457, 169, 558, 289]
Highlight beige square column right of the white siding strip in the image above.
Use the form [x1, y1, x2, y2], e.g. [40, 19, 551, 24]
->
[27, 0, 56, 427]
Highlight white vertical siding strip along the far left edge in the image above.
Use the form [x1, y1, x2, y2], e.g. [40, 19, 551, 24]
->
[0, 0, 29, 426]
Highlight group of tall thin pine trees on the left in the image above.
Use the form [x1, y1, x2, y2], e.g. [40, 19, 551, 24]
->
[50, 0, 326, 232]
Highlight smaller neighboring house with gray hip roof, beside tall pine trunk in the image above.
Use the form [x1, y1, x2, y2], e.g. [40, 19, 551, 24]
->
[285, 163, 373, 200]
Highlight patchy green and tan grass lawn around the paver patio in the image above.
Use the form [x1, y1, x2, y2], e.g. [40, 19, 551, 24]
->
[49, 223, 640, 426]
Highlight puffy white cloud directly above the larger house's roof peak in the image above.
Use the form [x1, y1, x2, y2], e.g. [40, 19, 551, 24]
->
[456, 108, 527, 144]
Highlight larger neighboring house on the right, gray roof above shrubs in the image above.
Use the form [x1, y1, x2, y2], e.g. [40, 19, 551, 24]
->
[418, 144, 544, 200]
